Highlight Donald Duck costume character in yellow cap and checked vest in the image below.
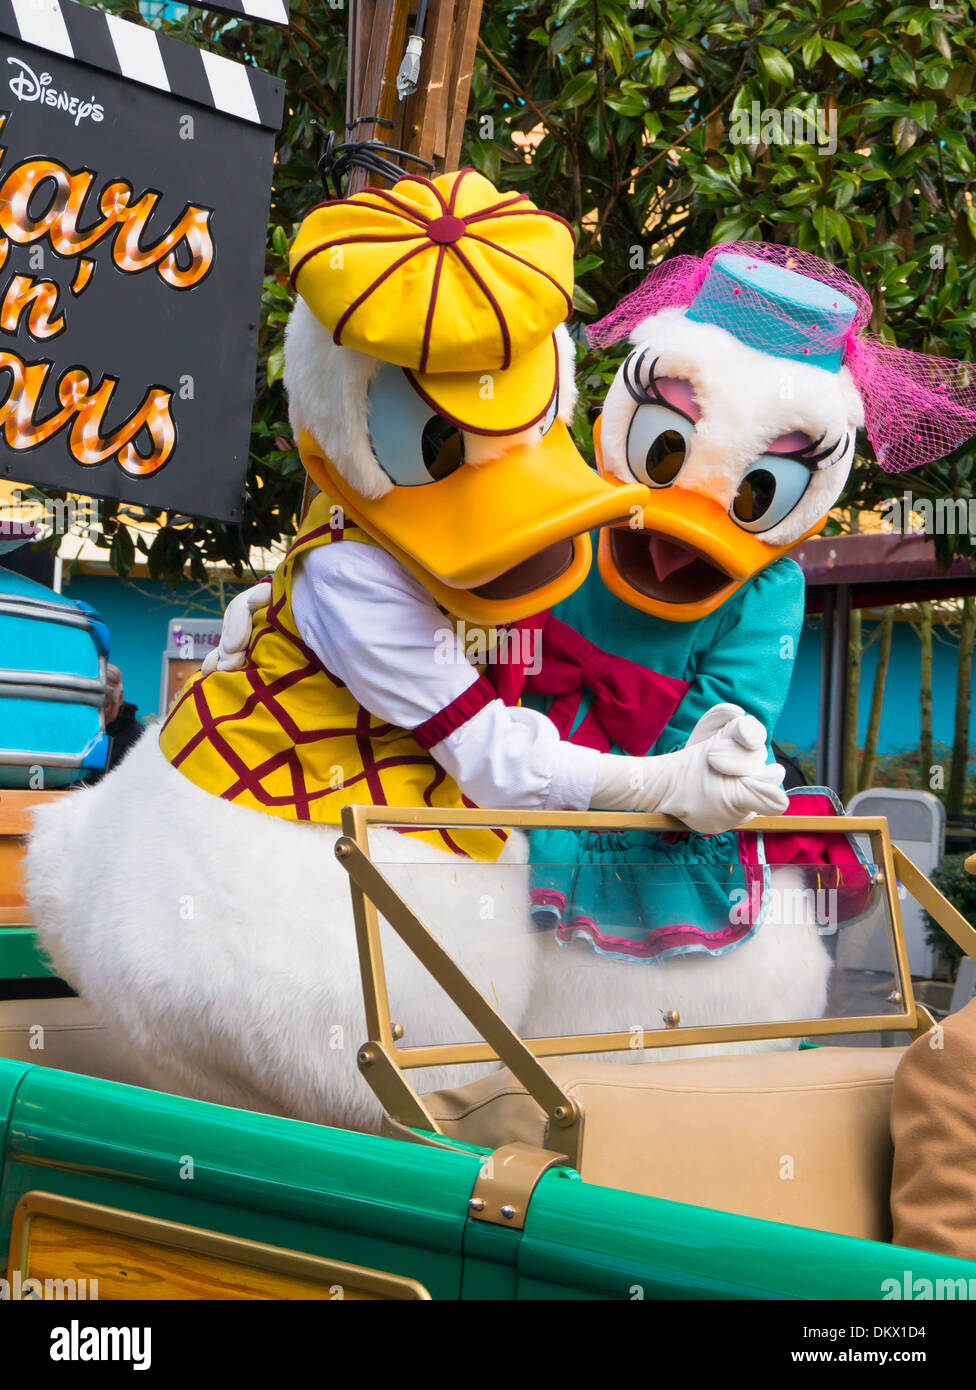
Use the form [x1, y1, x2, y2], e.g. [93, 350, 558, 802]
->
[26, 170, 784, 1127]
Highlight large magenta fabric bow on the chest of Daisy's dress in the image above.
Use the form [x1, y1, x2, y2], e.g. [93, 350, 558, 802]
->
[488, 613, 691, 758]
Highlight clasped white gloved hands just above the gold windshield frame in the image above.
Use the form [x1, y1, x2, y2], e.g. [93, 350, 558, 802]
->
[591, 705, 787, 835]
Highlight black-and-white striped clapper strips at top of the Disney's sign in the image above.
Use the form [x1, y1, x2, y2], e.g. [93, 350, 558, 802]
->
[0, 0, 288, 129]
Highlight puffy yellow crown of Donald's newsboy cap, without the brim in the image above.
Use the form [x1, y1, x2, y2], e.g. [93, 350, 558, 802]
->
[291, 170, 573, 375]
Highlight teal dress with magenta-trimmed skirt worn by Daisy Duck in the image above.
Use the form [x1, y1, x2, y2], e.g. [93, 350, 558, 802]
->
[526, 547, 804, 960]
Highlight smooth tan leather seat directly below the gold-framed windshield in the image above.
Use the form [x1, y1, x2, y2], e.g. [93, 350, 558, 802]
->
[424, 1047, 905, 1240]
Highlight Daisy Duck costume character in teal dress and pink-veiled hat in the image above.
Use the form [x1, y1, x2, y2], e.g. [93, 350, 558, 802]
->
[516, 243, 976, 1056]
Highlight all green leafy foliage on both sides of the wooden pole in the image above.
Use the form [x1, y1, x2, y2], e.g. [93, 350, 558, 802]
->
[59, 0, 976, 577]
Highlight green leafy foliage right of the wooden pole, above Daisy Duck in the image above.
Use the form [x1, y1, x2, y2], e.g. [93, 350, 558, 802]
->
[471, 0, 976, 522]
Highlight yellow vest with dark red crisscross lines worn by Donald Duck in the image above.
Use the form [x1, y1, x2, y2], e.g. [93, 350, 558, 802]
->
[160, 493, 506, 860]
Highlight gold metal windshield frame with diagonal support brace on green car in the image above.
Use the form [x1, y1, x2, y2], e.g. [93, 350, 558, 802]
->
[335, 806, 976, 1147]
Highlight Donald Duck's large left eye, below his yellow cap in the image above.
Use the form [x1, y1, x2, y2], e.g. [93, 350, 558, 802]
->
[367, 364, 464, 488]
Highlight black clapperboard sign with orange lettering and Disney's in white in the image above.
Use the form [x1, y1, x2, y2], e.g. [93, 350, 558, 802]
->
[0, 0, 288, 521]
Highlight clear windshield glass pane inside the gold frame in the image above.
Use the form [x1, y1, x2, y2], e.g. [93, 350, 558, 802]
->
[361, 811, 905, 1055]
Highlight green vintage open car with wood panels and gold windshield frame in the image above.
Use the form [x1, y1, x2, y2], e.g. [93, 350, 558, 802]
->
[0, 792, 976, 1300]
